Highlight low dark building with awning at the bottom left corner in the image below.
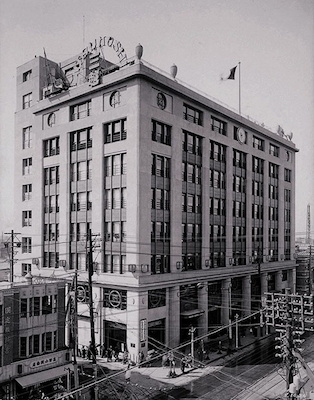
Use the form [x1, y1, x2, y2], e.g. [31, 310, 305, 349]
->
[0, 274, 71, 400]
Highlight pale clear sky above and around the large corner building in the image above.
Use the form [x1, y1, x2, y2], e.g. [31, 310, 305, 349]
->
[0, 0, 314, 237]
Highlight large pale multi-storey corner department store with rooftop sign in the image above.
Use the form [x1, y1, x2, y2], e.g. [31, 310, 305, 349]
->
[14, 37, 297, 357]
